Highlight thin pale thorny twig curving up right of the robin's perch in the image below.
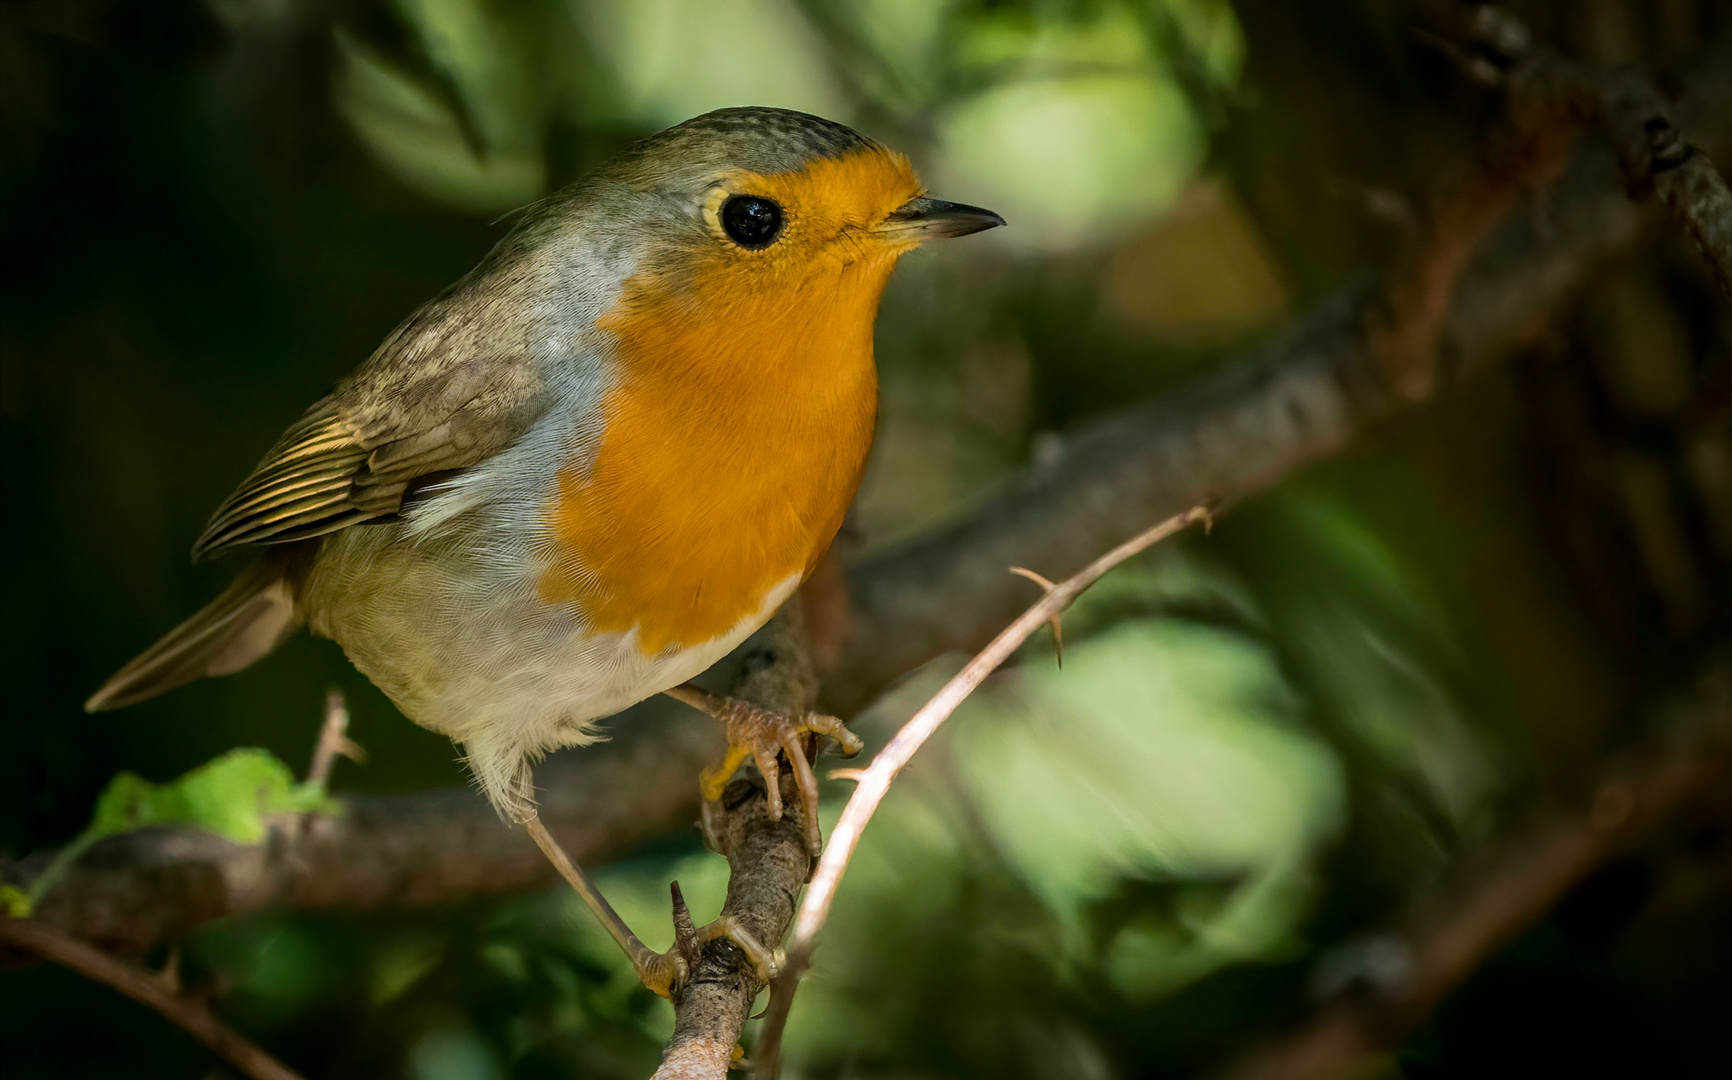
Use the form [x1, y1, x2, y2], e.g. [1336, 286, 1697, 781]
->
[753, 502, 1214, 1077]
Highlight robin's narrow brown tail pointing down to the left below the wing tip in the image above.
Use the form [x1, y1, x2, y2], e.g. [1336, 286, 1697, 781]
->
[85, 552, 305, 713]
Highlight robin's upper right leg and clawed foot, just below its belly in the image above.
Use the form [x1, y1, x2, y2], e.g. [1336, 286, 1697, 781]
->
[667, 682, 866, 855]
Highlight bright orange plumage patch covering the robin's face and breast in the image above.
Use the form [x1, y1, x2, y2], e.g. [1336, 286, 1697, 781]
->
[540, 149, 920, 654]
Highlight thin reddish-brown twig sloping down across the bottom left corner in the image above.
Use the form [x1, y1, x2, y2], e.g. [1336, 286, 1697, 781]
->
[0, 919, 301, 1080]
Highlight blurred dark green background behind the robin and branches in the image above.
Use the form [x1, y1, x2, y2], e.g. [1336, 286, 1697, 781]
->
[0, 0, 1732, 1080]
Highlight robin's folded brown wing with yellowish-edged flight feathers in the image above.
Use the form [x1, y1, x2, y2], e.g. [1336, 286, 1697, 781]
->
[192, 279, 547, 559]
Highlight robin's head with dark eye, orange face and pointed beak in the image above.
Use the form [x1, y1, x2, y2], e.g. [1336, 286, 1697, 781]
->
[509, 107, 1005, 365]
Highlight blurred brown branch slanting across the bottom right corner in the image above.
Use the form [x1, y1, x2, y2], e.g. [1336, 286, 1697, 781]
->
[1223, 640, 1732, 1080]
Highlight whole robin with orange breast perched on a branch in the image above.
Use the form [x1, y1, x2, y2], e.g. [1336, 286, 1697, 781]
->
[85, 107, 1005, 995]
